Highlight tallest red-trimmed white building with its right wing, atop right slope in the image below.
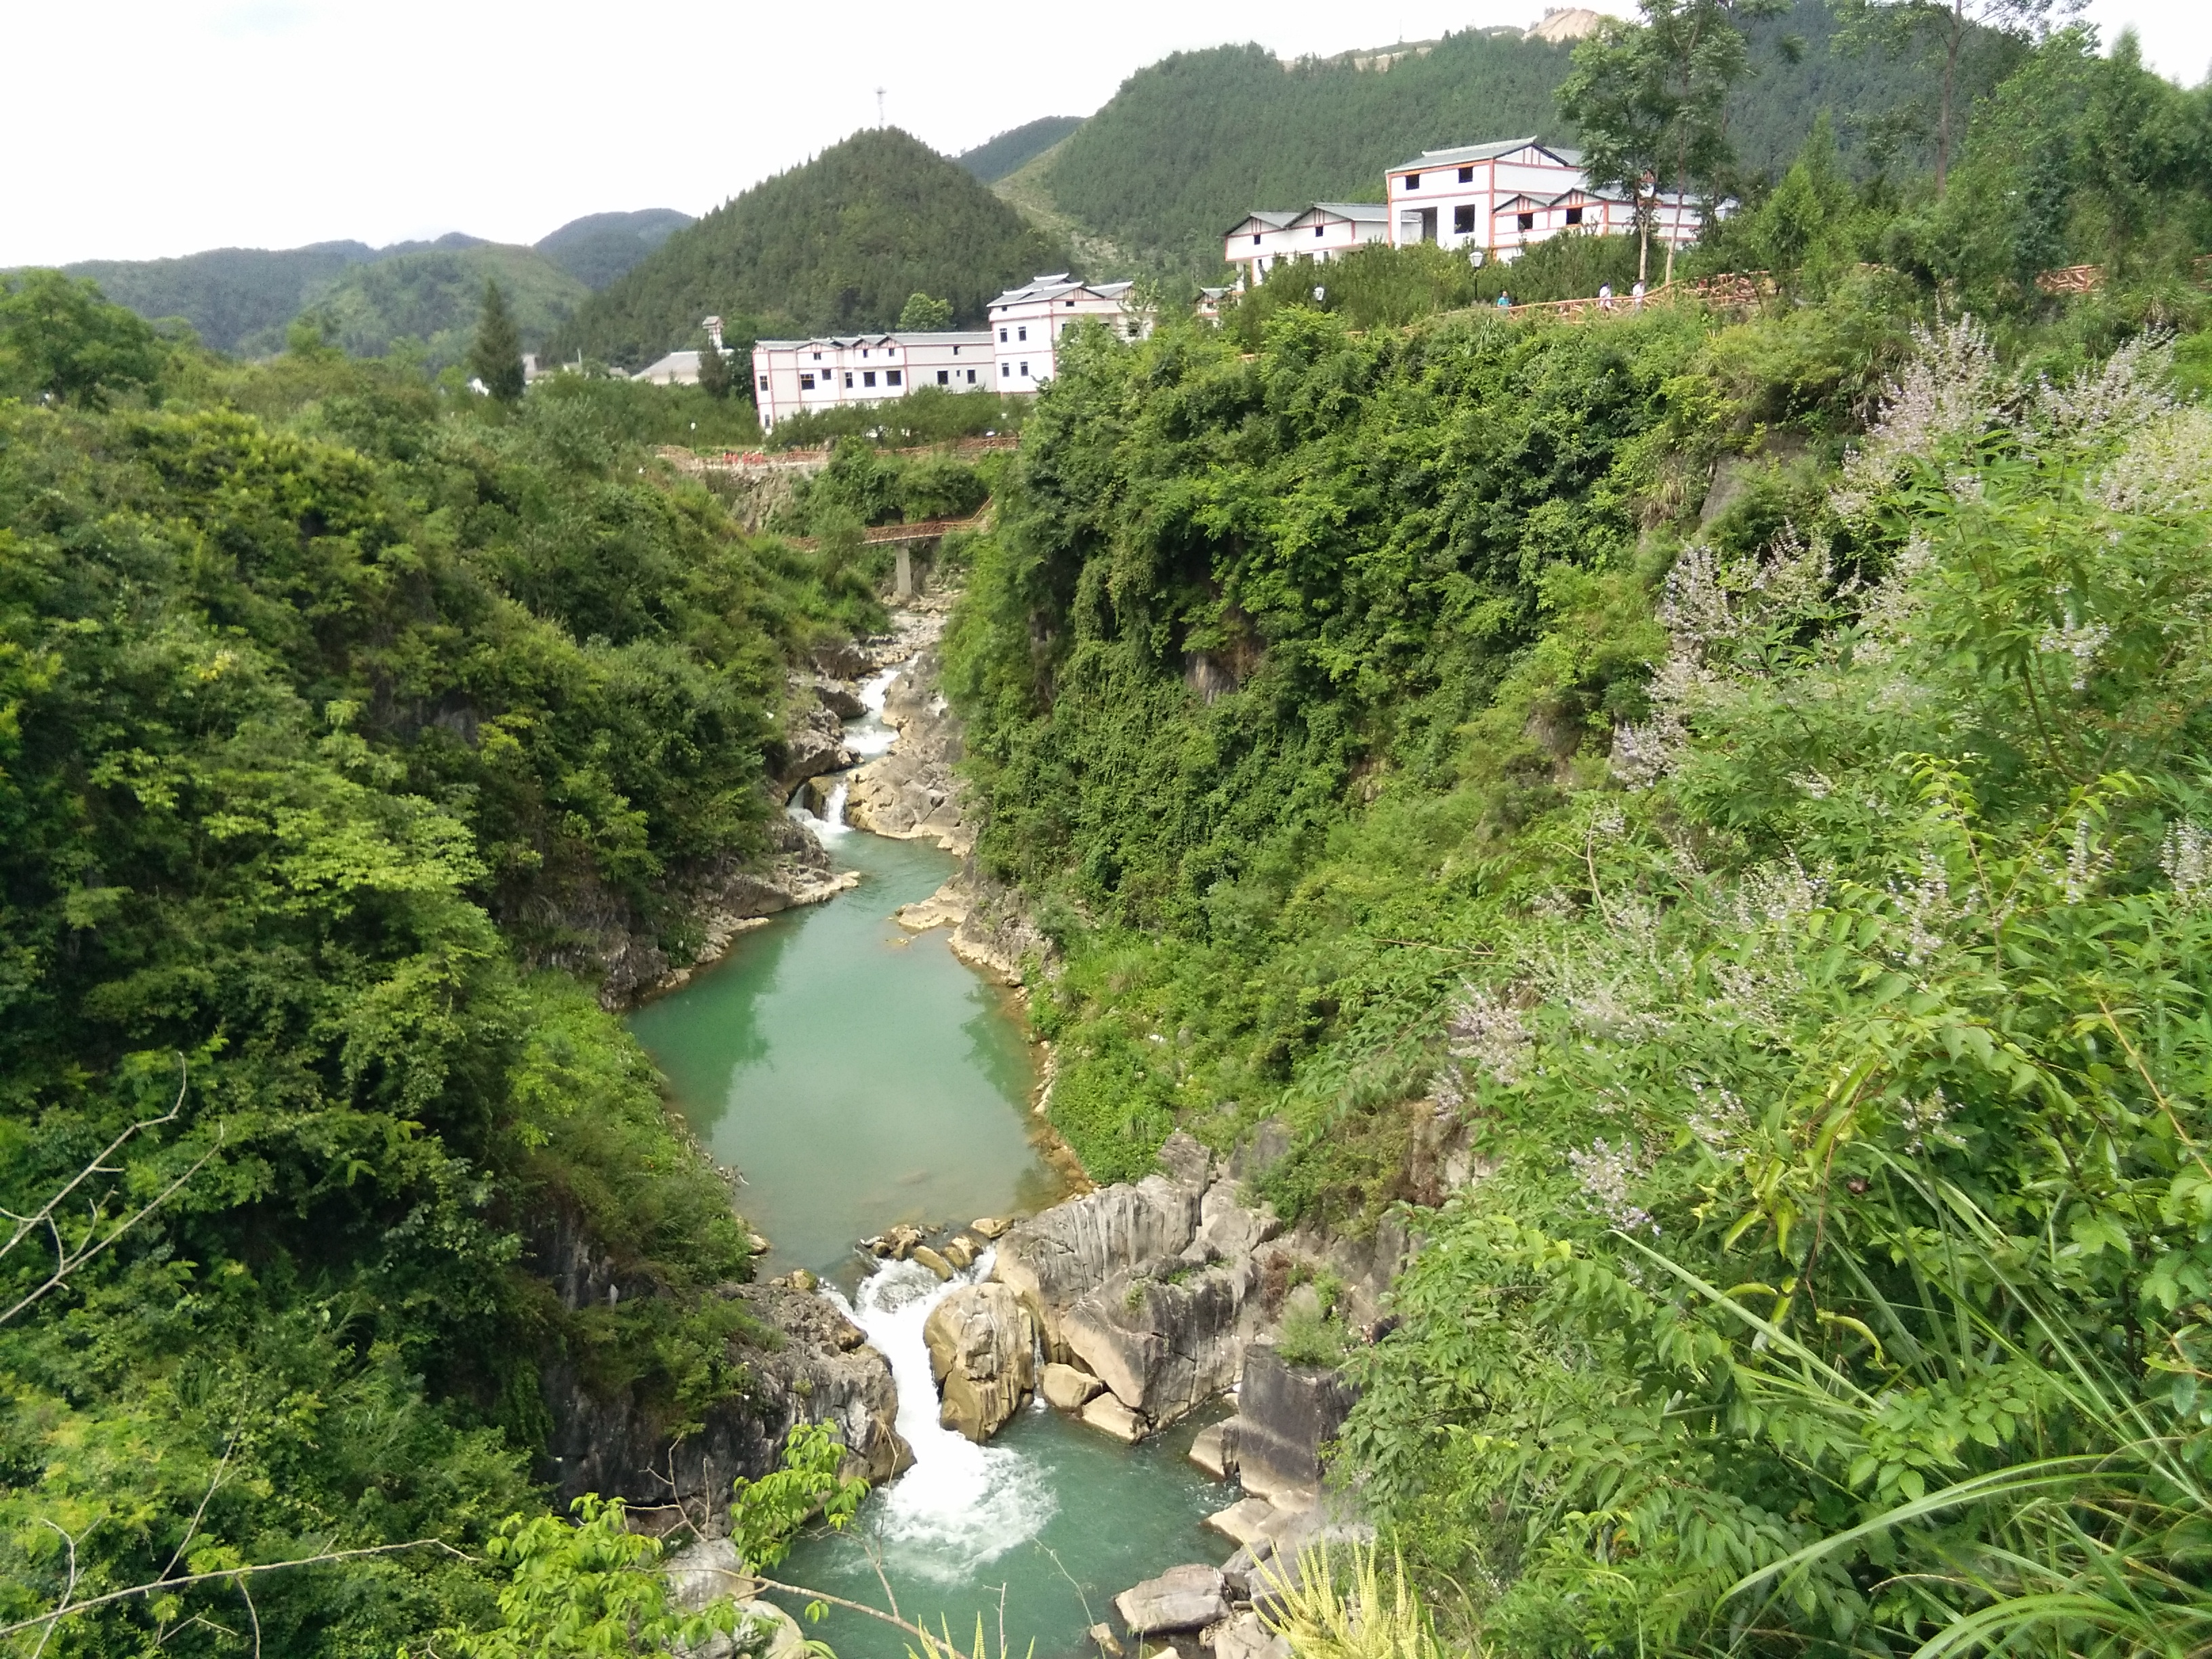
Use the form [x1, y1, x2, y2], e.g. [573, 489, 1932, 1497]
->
[1382, 137, 1703, 259]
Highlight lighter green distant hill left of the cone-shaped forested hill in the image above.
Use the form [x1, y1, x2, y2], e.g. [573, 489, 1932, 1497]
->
[272, 239, 590, 369]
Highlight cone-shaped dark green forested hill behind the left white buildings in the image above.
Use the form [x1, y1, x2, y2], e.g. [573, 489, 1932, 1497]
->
[548, 128, 1066, 369]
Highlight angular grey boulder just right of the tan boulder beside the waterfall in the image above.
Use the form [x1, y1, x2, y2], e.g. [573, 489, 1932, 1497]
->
[1059, 1256, 1258, 1427]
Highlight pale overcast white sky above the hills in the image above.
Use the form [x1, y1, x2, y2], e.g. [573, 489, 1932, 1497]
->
[0, 0, 2212, 268]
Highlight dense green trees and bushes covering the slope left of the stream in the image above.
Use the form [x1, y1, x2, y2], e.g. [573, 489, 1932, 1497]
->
[0, 274, 880, 1654]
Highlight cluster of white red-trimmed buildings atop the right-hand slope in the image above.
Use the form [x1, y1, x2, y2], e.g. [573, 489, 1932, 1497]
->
[1221, 137, 1703, 287]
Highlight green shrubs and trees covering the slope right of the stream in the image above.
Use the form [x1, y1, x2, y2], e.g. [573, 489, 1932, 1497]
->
[947, 19, 2212, 1654]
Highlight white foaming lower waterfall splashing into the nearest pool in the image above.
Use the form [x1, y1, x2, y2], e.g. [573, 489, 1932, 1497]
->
[823, 1252, 1059, 1584]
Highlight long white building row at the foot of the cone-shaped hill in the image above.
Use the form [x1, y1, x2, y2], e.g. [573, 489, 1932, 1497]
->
[752, 272, 1150, 431]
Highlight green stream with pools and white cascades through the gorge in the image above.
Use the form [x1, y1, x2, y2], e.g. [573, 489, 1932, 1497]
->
[633, 670, 1234, 1659]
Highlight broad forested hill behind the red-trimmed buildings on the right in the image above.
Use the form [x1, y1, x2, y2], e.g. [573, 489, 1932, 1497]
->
[1044, 0, 2009, 272]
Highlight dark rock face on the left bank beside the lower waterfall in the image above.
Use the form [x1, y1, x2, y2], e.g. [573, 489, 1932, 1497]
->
[531, 1208, 914, 1528]
